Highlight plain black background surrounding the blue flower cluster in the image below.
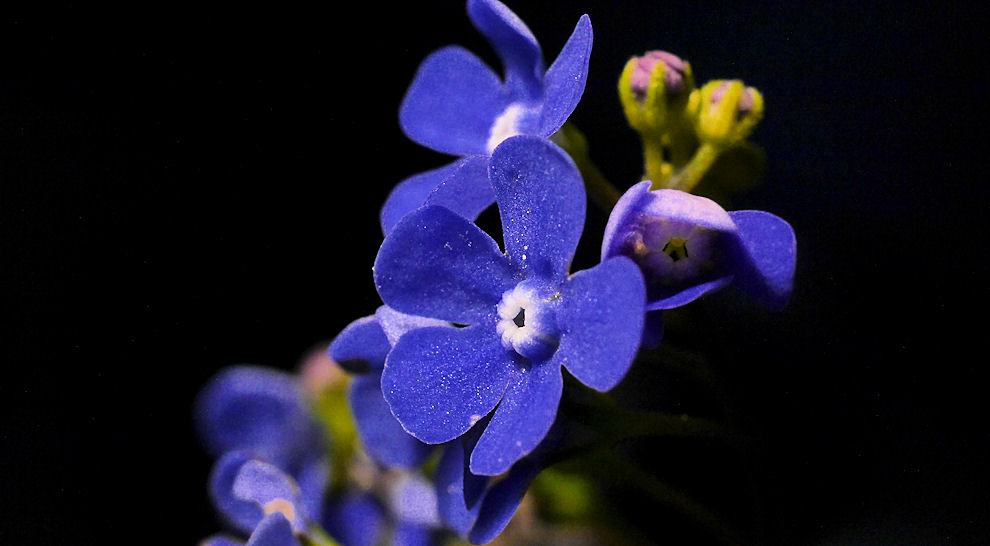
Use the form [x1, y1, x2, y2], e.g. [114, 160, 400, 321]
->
[0, 2, 990, 544]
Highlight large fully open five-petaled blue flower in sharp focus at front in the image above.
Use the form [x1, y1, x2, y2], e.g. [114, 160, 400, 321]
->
[374, 136, 645, 475]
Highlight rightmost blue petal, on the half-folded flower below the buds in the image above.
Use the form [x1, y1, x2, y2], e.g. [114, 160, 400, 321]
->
[729, 210, 797, 308]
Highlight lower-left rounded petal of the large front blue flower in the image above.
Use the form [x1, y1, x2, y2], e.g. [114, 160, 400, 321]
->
[382, 326, 513, 444]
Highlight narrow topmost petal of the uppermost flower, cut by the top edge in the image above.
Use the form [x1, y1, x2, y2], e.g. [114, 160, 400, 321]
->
[468, 0, 543, 99]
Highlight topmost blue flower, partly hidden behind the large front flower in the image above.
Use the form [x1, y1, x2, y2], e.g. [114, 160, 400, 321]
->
[381, 0, 592, 234]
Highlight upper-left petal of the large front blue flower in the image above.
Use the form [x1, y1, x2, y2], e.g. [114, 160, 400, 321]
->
[374, 203, 516, 324]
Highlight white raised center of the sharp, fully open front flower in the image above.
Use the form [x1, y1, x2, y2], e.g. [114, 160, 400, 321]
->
[495, 284, 558, 360]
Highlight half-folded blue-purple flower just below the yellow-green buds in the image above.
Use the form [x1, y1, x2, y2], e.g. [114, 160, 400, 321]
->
[602, 181, 797, 344]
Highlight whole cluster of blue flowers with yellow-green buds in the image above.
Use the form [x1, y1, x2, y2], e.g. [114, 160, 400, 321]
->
[197, 0, 796, 545]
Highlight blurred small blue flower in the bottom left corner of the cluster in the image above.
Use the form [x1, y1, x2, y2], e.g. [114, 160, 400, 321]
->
[203, 451, 313, 546]
